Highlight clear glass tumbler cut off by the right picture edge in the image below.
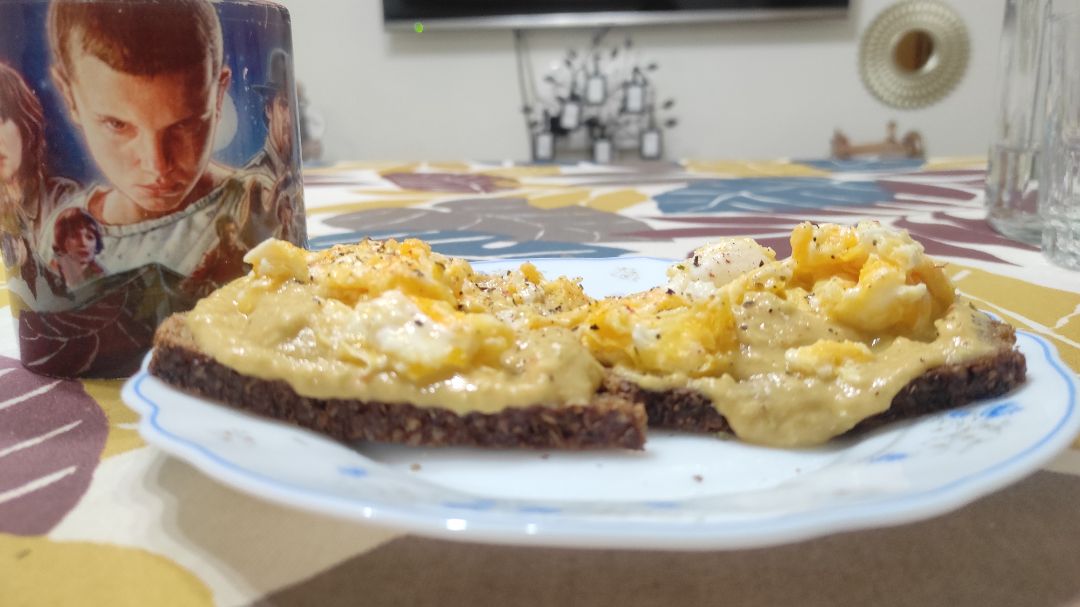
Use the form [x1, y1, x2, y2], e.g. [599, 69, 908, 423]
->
[1039, 11, 1080, 270]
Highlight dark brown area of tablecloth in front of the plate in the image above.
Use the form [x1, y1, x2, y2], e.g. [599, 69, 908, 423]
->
[262, 472, 1080, 607]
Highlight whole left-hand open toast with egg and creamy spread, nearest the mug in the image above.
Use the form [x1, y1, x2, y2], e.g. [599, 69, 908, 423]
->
[149, 236, 646, 449]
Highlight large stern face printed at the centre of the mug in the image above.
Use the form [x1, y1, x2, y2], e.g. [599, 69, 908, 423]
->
[57, 53, 230, 214]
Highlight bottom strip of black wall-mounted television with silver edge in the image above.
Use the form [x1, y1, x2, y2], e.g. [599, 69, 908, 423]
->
[382, 0, 849, 27]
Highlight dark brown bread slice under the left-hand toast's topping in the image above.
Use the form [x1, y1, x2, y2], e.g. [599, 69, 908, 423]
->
[150, 314, 646, 449]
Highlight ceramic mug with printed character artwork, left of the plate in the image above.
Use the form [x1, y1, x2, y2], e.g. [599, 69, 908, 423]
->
[0, 0, 307, 377]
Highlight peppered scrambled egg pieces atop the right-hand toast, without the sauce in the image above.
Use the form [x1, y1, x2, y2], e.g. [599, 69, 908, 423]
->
[582, 217, 955, 377]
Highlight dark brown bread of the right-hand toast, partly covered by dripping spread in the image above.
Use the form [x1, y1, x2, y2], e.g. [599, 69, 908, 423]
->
[604, 313, 1027, 435]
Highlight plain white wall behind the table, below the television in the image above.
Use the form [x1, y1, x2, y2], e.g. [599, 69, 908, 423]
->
[283, 0, 1004, 160]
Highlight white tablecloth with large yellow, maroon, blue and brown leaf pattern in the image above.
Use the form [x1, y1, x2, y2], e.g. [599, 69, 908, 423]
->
[0, 159, 1080, 606]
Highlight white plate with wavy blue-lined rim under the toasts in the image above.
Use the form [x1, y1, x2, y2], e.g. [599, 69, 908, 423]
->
[123, 258, 1080, 550]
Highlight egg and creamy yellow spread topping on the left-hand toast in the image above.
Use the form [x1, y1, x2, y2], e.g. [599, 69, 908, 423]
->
[187, 240, 604, 413]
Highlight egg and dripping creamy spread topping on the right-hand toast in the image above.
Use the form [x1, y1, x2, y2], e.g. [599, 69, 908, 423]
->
[579, 222, 1000, 446]
